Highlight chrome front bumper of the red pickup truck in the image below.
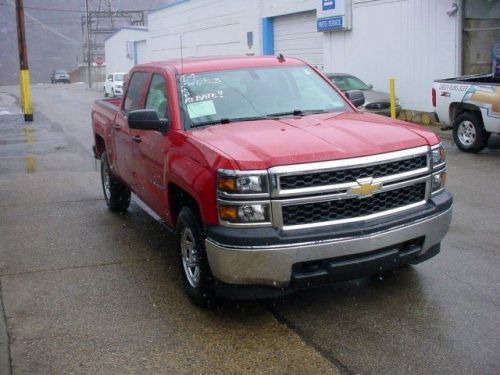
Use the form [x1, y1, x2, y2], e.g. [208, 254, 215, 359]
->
[205, 208, 452, 287]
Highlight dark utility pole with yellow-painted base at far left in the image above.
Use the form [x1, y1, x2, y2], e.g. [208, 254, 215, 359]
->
[16, 0, 33, 121]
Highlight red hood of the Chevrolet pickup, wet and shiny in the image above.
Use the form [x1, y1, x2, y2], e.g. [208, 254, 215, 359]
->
[191, 112, 439, 170]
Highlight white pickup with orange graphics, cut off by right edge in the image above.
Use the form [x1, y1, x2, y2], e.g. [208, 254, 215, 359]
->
[432, 74, 500, 152]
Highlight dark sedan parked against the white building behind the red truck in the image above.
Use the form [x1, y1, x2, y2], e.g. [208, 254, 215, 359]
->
[326, 73, 401, 116]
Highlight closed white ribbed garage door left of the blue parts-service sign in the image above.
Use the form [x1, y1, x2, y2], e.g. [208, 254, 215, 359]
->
[274, 11, 323, 68]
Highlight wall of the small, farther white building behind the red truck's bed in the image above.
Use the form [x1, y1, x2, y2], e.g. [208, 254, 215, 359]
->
[104, 28, 149, 74]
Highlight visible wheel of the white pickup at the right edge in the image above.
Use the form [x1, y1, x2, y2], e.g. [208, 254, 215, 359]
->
[453, 112, 490, 152]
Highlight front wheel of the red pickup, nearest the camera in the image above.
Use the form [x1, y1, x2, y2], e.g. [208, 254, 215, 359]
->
[176, 207, 215, 307]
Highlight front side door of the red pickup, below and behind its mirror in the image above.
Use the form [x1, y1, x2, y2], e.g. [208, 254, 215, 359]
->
[132, 72, 170, 216]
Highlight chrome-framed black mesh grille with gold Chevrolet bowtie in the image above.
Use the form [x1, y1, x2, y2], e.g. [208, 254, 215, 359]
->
[269, 146, 431, 230]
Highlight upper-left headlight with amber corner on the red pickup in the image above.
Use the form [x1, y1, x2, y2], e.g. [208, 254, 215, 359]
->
[217, 170, 269, 197]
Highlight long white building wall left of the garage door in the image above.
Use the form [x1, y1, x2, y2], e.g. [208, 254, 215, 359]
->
[148, 0, 261, 60]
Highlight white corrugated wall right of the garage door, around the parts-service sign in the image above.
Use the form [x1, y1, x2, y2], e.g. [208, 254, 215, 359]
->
[324, 0, 460, 111]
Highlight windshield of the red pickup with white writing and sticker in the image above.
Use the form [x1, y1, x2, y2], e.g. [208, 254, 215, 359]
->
[179, 66, 351, 128]
